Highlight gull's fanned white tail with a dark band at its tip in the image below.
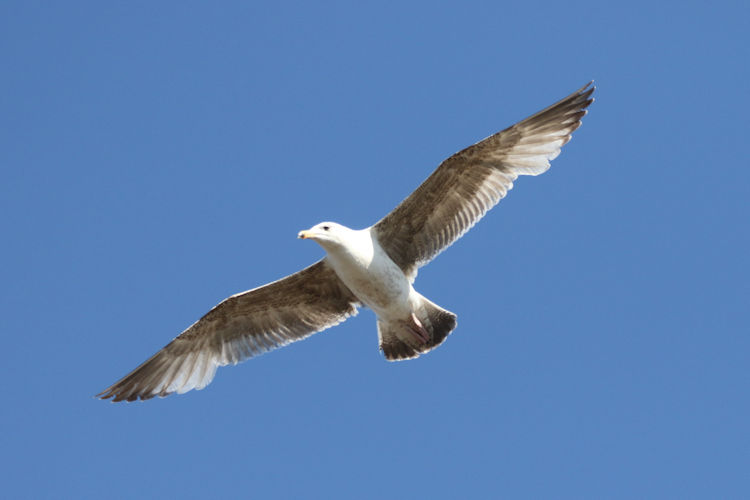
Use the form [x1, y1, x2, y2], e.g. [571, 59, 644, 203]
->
[378, 297, 456, 361]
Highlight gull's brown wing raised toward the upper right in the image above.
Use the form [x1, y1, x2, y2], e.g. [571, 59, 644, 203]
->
[374, 82, 595, 276]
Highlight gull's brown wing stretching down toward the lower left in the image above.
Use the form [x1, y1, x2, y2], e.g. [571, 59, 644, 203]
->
[97, 259, 359, 401]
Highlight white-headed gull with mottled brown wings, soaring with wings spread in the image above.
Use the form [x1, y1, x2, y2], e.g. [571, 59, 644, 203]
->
[97, 82, 595, 402]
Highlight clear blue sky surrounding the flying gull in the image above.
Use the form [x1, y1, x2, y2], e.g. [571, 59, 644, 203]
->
[0, 1, 750, 499]
